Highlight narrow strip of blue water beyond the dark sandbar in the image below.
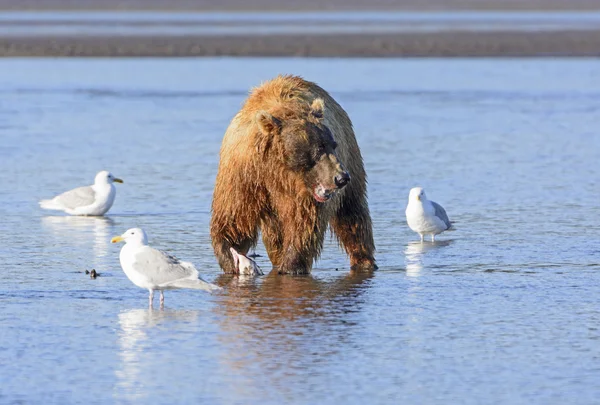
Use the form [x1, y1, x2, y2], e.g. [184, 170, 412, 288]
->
[0, 11, 600, 36]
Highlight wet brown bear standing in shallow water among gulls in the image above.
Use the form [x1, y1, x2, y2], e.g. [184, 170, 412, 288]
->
[210, 76, 376, 274]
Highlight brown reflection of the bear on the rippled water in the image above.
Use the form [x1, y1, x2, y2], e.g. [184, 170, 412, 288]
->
[214, 272, 374, 390]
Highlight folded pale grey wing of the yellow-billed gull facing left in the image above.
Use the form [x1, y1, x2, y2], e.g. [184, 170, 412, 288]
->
[133, 246, 198, 285]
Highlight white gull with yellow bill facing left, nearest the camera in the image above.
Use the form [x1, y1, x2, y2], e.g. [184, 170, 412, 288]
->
[111, 228, 221, 307]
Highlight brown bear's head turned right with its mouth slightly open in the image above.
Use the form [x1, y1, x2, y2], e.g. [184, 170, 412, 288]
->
[256, 98, 350, 203]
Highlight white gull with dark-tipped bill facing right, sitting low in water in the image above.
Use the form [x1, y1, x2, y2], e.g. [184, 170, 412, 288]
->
[39, 170, 123, 216]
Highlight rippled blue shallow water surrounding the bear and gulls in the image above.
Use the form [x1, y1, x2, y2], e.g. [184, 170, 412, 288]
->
[0, 58, 600, 404]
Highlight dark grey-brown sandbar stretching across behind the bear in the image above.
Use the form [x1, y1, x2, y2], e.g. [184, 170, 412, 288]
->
[0, 30, 600, 57]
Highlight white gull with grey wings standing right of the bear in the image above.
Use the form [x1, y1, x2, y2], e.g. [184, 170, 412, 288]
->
[406, 187, 452, 242]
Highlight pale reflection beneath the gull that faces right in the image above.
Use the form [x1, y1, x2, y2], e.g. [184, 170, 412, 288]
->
[42, 216, 115, 268]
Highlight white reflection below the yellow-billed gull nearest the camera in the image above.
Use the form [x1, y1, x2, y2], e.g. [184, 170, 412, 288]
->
[114, 309, 201, 401]
